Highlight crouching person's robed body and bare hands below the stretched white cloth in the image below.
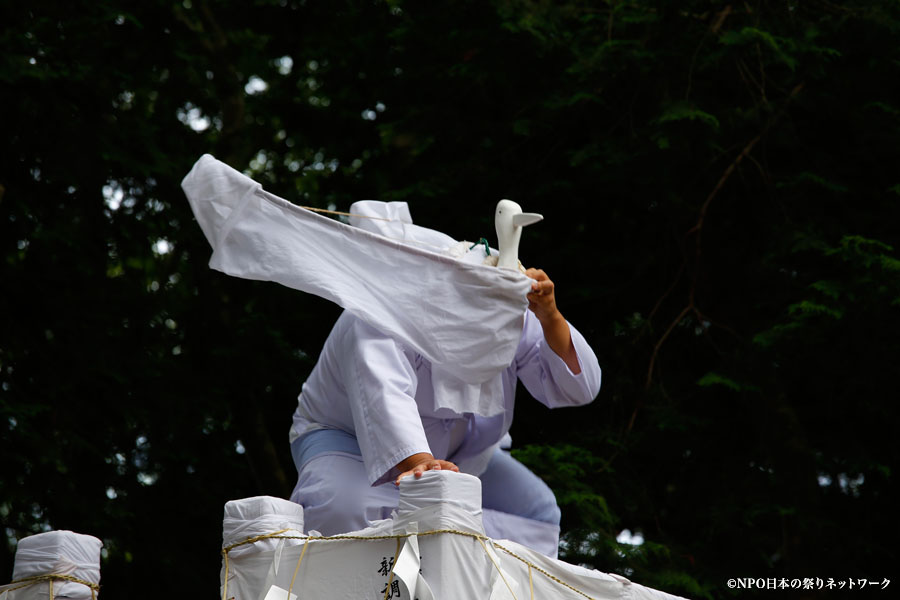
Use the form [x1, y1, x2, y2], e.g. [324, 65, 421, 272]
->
[290, 269, 600, 557]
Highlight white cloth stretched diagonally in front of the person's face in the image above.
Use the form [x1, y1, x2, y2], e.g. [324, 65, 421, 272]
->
[181, 154, 531, 416]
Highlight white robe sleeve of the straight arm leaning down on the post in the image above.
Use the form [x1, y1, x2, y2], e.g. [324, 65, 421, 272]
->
[341, 319, 431, 485]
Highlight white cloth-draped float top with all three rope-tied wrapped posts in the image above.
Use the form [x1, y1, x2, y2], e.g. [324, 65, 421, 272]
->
[0, 482, 678, 600]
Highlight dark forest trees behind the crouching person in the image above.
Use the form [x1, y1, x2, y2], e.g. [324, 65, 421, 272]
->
[0, 0, 900, 598]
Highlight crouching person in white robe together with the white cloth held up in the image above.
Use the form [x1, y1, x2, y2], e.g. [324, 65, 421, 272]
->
[182, 155, 600, 556]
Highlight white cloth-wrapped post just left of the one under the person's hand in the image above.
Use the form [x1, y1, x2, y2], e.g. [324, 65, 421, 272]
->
[219, 496, 304, 594]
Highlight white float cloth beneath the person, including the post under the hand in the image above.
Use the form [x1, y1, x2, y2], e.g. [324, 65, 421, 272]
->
[220, 471, 688, 600]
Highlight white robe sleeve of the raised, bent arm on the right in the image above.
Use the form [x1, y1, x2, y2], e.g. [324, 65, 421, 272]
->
[516, 310, 600, 408]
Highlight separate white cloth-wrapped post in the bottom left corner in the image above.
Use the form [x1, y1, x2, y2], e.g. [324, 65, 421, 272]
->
[0, 531, 103, 600]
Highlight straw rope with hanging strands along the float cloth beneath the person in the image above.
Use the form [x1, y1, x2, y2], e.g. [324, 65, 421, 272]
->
[222, 529, 596, 600]
